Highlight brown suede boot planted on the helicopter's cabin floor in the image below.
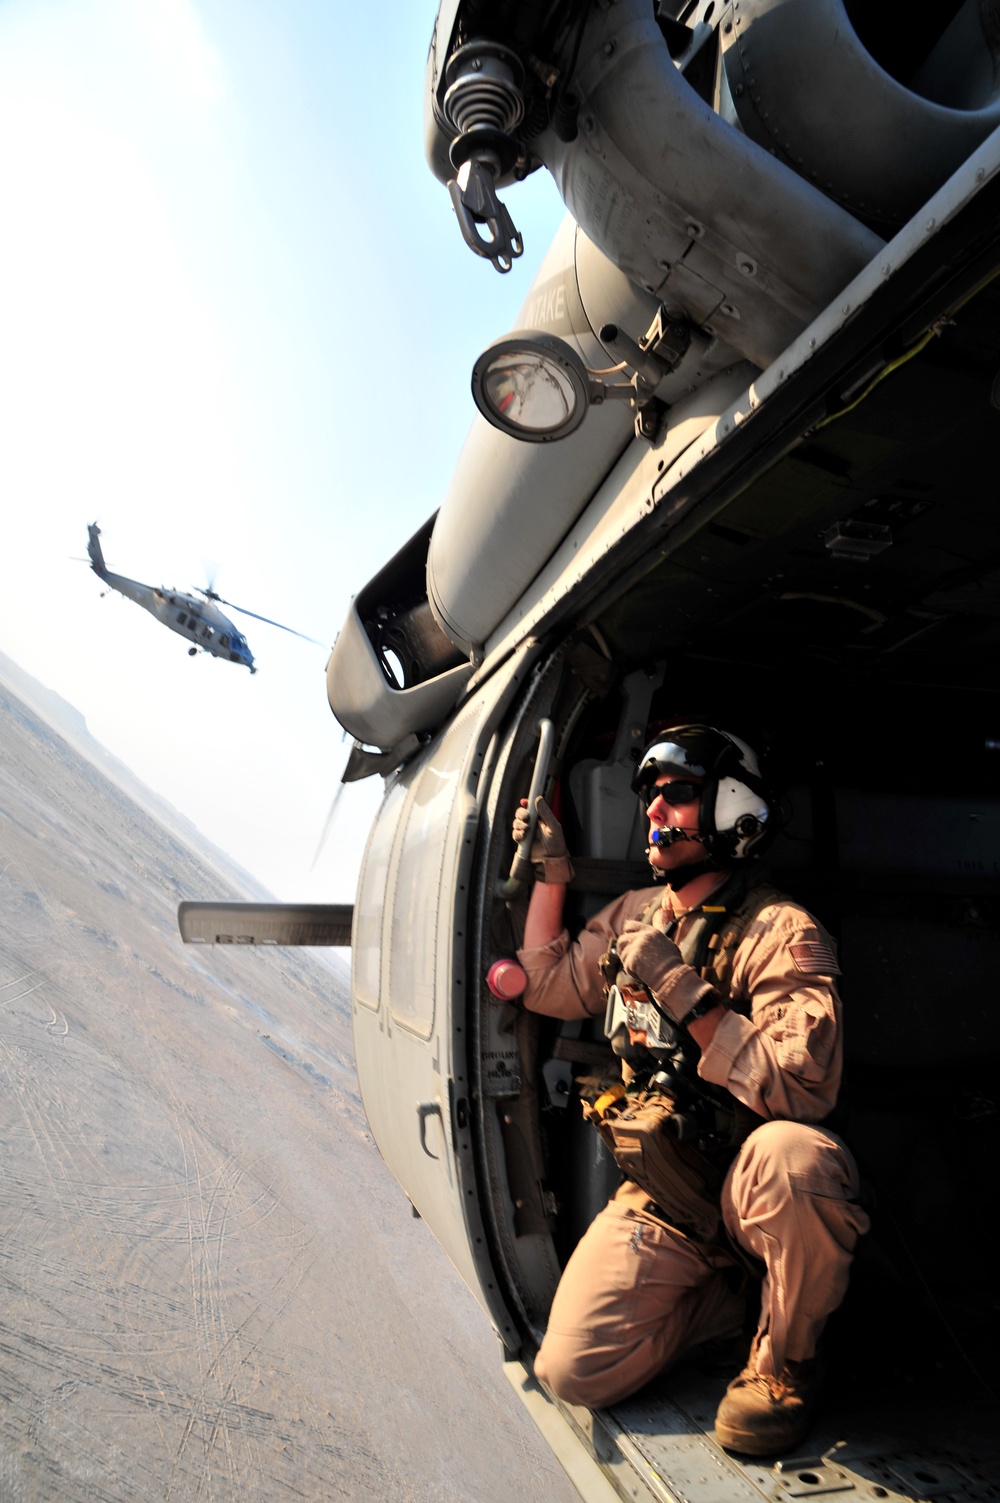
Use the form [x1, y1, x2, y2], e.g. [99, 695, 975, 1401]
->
[716, 1357, 823, 1456]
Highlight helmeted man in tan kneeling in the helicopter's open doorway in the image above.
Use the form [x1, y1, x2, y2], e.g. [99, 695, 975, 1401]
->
[514, 724, 868, 1455]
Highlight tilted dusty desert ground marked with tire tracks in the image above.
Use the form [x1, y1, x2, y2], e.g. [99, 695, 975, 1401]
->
[0, 678, 577, 1503]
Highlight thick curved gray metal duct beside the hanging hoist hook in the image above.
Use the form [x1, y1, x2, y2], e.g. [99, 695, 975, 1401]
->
[517, 0, 880, 365]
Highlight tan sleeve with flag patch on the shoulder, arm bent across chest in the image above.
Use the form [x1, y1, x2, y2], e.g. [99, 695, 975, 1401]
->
[698, 903, 842, 1121]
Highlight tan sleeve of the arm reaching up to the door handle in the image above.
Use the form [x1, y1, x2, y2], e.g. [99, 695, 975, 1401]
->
[517, 888, 659, 1018]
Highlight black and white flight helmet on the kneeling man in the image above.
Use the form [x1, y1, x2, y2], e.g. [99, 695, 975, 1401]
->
[632, 724, 774, 870]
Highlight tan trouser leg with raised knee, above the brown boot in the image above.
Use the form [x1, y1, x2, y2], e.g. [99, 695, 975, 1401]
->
[722, 1121, 868, 1375]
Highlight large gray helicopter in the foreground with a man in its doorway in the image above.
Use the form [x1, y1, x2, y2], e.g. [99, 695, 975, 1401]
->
[179, 0, 1000, 1503]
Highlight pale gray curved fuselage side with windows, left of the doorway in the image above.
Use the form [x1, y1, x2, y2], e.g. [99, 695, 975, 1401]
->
[352, 655, 523, 1351]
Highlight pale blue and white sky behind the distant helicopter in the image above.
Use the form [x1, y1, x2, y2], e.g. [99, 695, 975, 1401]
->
[0, 0, 562, 900]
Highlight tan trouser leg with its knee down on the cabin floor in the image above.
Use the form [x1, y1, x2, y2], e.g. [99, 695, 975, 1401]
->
[535, 1201, 744, 1408]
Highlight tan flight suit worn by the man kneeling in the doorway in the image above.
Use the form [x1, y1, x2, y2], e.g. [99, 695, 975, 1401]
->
[519, 878, 868, 1408]
